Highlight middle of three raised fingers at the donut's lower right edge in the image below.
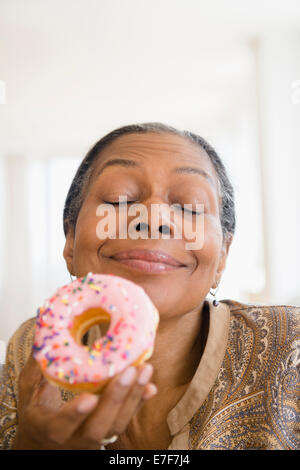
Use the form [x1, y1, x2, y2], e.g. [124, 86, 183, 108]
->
[112, 364, 153, 435]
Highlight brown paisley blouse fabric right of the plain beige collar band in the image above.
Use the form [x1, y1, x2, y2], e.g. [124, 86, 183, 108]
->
[193, 299, 300, 450]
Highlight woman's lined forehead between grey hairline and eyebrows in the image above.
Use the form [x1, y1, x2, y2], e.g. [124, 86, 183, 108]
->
[91, 132, 220, 193]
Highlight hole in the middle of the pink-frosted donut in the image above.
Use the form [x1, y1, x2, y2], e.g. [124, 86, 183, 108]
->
[70, 307, 110, 346]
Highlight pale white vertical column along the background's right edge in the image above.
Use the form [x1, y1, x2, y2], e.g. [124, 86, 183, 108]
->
[257, 31, 300, 303]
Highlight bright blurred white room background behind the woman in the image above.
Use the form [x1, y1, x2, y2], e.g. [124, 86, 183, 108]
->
[0, 0, 300, 362]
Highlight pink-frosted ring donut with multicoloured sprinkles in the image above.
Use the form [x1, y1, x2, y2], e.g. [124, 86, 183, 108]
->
[33, 273, 159, 393]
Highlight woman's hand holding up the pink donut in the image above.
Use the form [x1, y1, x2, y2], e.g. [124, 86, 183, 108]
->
[13, 357, 157, 449]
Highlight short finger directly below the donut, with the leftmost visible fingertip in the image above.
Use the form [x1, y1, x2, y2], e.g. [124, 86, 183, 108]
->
[47, 393, 99, 444]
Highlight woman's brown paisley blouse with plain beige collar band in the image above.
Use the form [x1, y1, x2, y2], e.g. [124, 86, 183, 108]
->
[0, 300, 300, 450]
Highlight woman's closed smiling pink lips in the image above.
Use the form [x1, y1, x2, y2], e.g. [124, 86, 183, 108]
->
[110, 250, 186, 274]
